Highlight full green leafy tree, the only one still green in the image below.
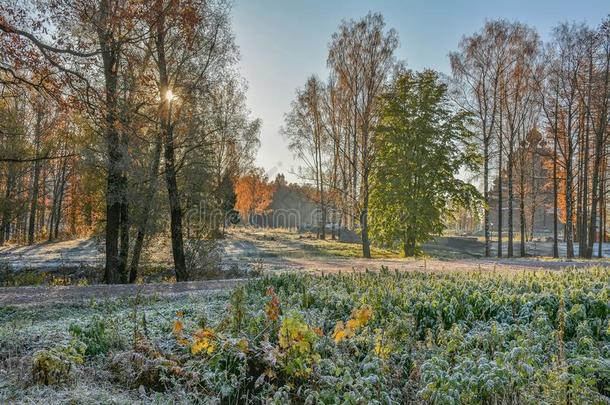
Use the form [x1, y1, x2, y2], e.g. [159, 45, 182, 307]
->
[371, 70, 480, 256]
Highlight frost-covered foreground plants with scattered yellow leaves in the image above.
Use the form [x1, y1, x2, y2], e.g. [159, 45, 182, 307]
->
[0, 268, 610, 404]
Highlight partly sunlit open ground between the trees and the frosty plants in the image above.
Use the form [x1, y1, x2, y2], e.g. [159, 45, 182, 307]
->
[0, 228, 608, 306]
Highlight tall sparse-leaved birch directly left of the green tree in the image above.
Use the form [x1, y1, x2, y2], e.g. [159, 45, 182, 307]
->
[328, 13, 398, 258]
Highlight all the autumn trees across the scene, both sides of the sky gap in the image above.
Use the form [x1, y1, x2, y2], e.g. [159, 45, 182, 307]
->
[0, 0, 610, 283]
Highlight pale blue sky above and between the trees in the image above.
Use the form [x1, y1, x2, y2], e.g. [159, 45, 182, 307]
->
[233, 0, 610, 181]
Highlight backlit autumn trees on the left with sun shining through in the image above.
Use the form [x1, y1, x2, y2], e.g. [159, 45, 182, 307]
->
[0, 1, 259, 282]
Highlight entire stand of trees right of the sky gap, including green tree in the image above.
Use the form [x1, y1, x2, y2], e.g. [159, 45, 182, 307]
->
[283, 14, 610, 257]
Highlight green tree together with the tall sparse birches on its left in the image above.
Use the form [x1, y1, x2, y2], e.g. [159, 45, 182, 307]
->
[283, 14, 477, 257]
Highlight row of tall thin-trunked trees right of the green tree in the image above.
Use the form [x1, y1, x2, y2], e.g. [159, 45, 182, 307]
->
[450, 18, 610, 258]
